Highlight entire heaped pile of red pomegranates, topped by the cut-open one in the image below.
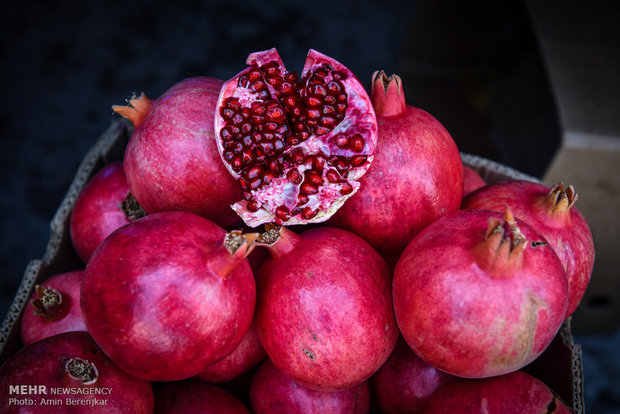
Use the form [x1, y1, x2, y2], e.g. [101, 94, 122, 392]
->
[0, 49, 594, 413]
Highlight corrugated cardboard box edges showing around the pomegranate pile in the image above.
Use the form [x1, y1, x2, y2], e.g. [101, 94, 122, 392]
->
[0, 120, 583, 413]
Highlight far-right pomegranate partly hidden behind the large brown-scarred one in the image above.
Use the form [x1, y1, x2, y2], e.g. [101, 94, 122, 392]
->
[463, 181, 594, 318]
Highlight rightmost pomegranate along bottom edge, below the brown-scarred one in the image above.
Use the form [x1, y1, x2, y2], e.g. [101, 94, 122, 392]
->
[424, 371, 571, 414]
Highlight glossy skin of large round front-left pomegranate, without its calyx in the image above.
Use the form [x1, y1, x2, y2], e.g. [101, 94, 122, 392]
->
[81, 212, 256, 381]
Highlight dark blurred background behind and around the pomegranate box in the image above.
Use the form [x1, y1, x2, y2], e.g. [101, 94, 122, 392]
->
[0, 0, 620, 413]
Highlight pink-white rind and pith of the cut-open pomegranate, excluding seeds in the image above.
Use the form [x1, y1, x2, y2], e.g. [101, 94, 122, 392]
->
[214, 48, 377, 227]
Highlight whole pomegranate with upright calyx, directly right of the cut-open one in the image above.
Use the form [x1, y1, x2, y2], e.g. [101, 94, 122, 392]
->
[330, 71, 463, 258]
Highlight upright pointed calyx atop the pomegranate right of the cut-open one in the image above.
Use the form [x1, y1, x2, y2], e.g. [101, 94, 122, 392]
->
[370, 70, 407, 116]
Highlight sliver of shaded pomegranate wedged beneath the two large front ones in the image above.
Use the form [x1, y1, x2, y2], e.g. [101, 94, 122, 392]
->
[196, 323, 267, 384]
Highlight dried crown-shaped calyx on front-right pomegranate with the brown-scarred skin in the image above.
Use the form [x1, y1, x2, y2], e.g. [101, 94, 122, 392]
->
[475, 207, 527, 278]
